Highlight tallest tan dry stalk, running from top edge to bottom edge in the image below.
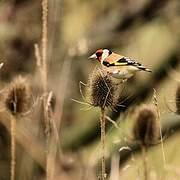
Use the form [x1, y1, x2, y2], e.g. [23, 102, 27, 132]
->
[38, 0, 54, 180]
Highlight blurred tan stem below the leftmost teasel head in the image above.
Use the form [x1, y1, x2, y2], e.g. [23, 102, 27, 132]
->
[11, 117, 16, 180]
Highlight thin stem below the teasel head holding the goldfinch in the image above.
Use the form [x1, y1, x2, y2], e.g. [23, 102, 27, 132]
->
[100, 107, 106, 180]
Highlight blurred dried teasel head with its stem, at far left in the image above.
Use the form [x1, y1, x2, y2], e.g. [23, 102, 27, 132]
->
[5, 77, 31, 180]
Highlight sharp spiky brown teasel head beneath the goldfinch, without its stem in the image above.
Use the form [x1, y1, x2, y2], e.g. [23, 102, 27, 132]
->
[87, 68, 118, 108]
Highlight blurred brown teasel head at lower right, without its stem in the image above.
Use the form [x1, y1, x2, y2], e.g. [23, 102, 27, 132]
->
[133, 105, 159, 146]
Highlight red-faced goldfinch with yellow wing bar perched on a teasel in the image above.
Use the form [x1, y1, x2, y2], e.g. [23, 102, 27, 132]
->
[89, 49, 152, 81]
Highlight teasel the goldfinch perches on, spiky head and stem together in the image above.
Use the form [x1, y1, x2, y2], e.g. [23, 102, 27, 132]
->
[87, 68, 119, 180]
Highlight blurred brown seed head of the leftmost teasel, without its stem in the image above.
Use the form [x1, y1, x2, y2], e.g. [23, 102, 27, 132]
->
[5, 76, 31, 115]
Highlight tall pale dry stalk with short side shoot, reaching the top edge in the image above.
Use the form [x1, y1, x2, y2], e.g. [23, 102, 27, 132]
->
[34, 0, 52, 179]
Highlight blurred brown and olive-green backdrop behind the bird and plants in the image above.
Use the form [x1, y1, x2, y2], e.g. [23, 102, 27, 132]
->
[0, 0, 180, 180]
